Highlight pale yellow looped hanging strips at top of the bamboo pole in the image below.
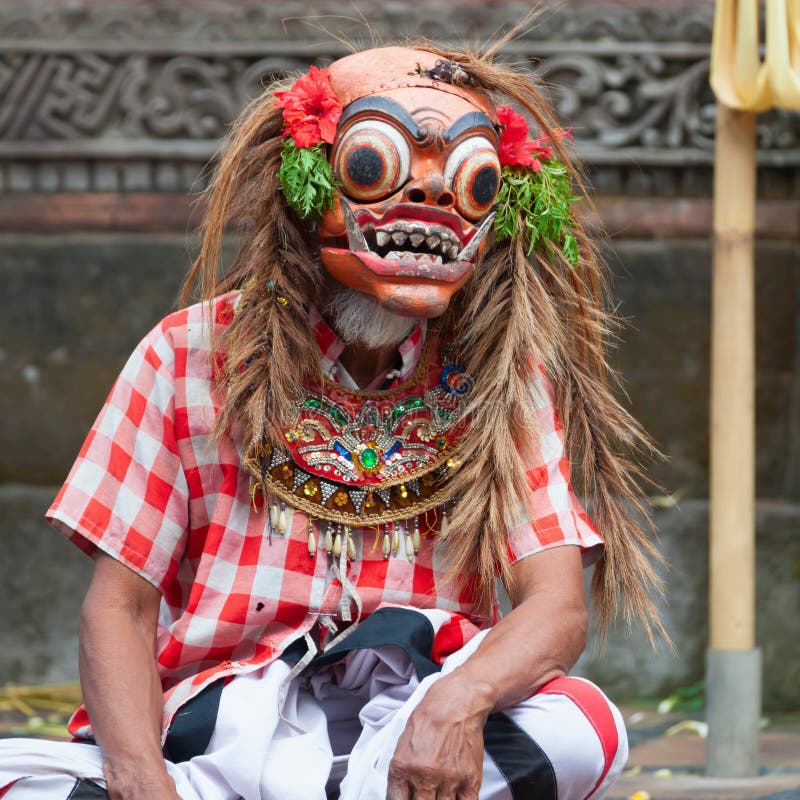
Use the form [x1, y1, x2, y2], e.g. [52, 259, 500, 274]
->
[711, 0, 800, 111]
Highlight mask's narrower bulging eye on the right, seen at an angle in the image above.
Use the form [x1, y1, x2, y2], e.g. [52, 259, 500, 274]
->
[444, 136, 500, 220]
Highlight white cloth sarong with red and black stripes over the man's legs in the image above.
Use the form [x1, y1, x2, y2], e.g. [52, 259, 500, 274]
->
[0, 620, 627, 800]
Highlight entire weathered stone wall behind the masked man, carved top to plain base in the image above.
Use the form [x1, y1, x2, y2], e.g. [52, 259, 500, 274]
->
[0, 0, 800, 710]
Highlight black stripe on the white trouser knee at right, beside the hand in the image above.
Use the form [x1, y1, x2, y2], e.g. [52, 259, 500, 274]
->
[483, 713, 558, 800]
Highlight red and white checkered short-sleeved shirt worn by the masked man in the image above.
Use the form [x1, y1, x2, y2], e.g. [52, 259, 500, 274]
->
[47, 295, 602, 736]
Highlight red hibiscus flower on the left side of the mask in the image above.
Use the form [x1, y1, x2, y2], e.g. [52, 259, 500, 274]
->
[275, 67, 342, 147]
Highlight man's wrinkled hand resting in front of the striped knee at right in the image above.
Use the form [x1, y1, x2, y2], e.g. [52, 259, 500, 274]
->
[386, 670, 494, 800]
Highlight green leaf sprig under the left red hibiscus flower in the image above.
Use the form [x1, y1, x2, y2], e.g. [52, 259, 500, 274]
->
[278, 136, 337, 222]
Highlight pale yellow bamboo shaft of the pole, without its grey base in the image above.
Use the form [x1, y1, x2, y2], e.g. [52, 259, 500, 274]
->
[710, 105, 756, 650]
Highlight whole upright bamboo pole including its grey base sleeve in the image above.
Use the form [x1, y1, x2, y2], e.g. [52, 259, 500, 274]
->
[706, 103, 760, 776]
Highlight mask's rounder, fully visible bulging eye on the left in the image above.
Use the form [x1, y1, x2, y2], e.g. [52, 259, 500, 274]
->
[333, 120, 410, 201]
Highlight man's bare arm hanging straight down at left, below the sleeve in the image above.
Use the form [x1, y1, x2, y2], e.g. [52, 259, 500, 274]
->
[80, 554, 178, 800]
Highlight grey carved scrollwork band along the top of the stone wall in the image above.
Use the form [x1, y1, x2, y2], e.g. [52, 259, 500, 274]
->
[0, 0, 800, 197]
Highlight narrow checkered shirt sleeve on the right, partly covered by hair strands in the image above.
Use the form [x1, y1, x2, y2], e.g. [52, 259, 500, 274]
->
[508, 371, 603, 567]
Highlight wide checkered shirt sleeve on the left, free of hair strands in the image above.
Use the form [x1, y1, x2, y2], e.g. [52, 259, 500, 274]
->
[45, 326, 188, 593]
